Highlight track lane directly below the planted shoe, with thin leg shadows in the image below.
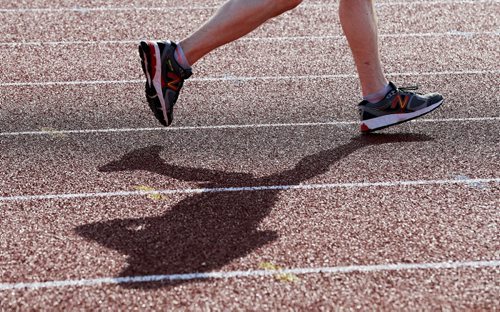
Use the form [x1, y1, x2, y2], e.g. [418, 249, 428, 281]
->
[0, 121, 500, 196]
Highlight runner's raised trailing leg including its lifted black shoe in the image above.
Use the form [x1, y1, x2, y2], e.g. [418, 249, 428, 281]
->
[139, 0, 302, 126]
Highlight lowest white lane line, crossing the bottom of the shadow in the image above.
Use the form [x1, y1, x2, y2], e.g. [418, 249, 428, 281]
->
[0, 260, 500, 291]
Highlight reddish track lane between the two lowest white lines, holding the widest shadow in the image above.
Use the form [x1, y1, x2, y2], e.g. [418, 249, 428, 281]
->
[1, 184, 500, 286]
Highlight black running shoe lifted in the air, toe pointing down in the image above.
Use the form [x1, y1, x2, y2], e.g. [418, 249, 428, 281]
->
[139, 41, 192, 127]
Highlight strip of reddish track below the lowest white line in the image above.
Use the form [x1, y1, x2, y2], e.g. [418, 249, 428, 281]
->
[1, 269, 499, 310]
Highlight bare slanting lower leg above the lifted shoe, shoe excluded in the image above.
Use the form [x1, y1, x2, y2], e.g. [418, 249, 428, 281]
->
[180, 0, 302, 65]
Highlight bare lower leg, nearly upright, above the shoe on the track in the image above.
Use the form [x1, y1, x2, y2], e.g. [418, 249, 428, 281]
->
[339, 0, 388, 96]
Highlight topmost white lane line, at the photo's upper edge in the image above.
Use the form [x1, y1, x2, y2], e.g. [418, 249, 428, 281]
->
[0, 0, 499, 13]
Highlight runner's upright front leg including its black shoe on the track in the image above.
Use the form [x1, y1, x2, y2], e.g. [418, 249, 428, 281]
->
[339, 0, 443, 133]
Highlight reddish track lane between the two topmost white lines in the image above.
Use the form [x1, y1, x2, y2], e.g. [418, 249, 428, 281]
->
[0, 1, 498, 42]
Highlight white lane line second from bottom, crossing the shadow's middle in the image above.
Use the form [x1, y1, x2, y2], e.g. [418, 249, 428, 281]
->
[0, 178, 500, 202]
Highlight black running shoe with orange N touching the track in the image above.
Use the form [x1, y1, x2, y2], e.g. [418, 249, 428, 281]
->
[359, 82, 444, 133]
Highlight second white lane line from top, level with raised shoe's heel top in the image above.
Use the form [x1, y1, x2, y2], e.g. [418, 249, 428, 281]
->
[0, 31, 500, 47]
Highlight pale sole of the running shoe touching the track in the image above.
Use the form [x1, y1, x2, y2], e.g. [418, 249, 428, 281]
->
[361, 100, 444, 133]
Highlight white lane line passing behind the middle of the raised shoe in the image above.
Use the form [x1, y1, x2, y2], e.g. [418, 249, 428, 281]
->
[0, 70, 500, 87]
